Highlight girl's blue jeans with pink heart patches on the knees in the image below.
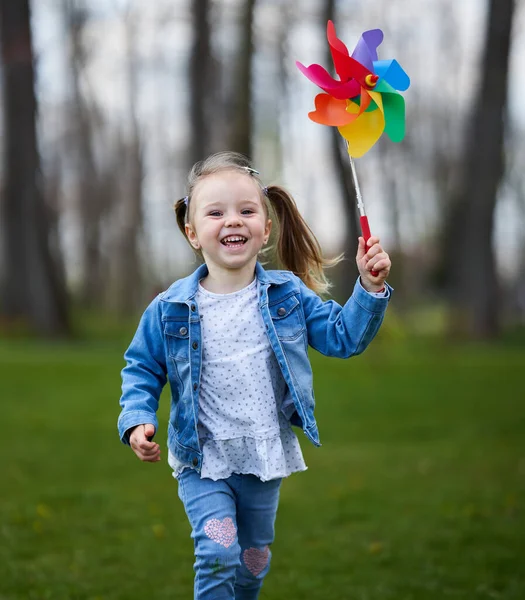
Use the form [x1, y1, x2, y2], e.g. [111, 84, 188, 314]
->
[177, 469, 281, 600]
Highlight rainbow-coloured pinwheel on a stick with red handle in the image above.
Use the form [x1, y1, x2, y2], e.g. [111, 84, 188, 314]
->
[296, 21, 410, 270]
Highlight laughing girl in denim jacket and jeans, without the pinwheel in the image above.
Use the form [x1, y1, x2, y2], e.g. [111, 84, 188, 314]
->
[118, 152, 391, 600]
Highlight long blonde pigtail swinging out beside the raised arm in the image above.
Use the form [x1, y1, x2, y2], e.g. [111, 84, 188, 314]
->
[265, 185, 343, 294]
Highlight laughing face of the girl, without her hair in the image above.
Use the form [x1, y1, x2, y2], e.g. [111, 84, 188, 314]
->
[186, 169, 272, 269]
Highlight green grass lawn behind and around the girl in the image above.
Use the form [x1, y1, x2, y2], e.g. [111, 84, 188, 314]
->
[0, 339, 525, 600]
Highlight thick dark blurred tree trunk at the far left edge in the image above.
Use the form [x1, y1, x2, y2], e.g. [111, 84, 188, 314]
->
[0, 0, 69, 336]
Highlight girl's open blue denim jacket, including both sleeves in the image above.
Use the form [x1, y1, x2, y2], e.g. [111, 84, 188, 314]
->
[118, 263, 392, 471]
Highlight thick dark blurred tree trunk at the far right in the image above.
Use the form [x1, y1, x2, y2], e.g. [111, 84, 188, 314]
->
[445, 0, 514, 338]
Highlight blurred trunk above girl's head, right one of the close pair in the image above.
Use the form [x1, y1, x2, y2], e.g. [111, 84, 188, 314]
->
[229, 0, 255, 157]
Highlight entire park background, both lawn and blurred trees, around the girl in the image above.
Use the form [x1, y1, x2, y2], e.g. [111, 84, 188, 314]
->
[0, 0, 525, 600]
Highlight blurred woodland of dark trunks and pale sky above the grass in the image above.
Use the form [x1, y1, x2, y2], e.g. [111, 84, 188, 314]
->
[1, 0, 525, 338]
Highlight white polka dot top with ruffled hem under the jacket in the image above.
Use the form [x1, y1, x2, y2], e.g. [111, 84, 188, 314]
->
[170, 279, 306, 481]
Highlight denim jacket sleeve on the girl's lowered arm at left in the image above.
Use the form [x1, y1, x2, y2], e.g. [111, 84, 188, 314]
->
[118, 297, 166, 445]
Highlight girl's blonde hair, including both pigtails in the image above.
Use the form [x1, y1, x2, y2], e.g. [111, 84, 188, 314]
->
[175, 152, 343, 294]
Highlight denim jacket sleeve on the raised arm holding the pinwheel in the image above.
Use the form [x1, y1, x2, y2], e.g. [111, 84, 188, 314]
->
[300, 279, 393, 358]
